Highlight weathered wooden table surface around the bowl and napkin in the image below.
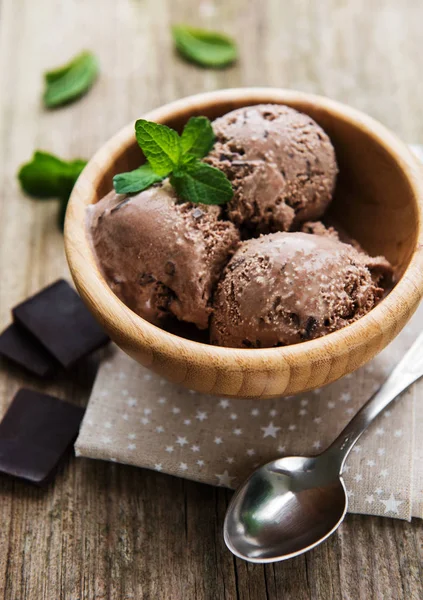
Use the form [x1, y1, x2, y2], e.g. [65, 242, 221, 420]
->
[0, 0, 423, 600]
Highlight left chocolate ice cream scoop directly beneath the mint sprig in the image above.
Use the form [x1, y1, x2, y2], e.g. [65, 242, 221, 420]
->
[89, 182, 239, 329]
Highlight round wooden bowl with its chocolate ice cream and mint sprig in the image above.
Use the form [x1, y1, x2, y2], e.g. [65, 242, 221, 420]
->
[65, 88, 423, 398]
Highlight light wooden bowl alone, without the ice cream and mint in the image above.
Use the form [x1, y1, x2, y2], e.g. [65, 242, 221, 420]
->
[65, 88, 423, 398]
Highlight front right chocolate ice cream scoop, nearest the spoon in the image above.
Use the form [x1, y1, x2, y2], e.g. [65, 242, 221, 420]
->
[211, 232, 389, 348]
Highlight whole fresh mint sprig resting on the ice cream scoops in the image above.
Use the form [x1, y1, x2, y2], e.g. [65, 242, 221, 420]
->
[113, 117, 233, 204]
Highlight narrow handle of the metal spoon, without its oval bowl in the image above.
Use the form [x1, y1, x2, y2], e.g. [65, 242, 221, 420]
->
[325, 333, 423, 472]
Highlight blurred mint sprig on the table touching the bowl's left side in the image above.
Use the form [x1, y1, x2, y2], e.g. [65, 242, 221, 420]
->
[18, 151, 87, 226]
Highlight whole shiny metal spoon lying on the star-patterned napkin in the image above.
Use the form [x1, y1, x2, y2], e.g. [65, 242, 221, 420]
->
[224, 333, 423, 563]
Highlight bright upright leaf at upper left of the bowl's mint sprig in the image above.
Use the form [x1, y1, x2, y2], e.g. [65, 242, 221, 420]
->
[135, 119, 181, 177]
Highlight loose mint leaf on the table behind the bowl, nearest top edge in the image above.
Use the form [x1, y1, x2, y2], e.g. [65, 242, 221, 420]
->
[172, 25, 238, 68]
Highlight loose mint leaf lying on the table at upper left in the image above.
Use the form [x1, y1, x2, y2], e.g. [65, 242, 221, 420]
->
[43, 51, 99, 108]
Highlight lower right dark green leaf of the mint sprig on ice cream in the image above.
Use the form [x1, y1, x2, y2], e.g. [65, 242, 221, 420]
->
[170, 160, 233, 204]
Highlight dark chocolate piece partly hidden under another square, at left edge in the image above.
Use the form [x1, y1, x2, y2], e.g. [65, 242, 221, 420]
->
[0, 324, 59, 377]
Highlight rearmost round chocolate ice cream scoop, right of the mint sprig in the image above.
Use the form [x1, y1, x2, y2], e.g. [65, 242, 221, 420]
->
[205, 104, 338, 237]
